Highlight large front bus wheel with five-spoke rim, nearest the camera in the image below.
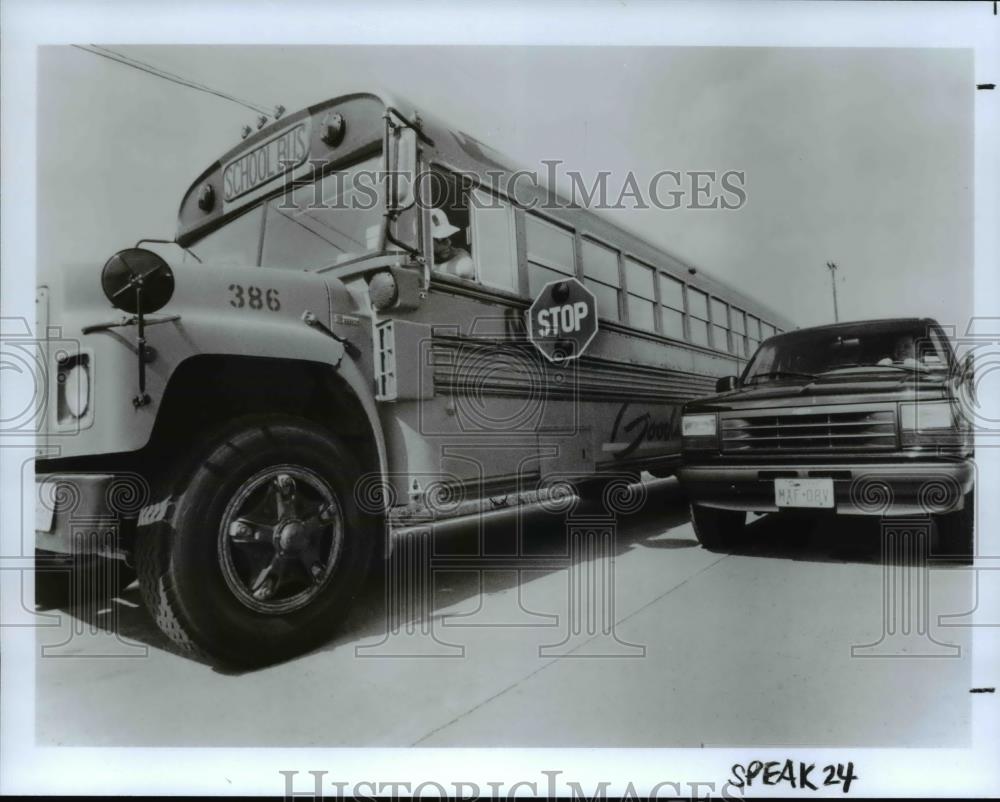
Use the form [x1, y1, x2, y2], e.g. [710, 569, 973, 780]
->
[136, 416, 378, 666]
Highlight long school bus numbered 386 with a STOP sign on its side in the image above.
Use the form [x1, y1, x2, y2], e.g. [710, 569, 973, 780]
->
[36, 92, 791, 664]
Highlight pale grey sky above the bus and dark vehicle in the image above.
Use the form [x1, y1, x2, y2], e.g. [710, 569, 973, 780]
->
[38, 45, 975, 331]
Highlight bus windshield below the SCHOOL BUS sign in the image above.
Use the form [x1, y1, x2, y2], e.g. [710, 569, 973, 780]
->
[189, 156, 385, 270]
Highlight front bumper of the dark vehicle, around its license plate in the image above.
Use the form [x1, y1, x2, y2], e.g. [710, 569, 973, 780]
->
[677, 459, 975, 515]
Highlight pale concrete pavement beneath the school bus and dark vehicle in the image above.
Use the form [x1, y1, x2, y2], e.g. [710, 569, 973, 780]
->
[36, 481, 973, 747]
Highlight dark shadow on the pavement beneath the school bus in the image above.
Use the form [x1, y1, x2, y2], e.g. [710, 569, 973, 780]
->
[36, 480, 698, 674]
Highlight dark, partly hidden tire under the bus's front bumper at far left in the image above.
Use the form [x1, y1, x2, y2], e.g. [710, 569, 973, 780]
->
[35, 552, 135, 609]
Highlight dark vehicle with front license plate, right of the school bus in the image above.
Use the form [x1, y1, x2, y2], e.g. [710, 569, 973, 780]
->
[678, 318, 975, 562]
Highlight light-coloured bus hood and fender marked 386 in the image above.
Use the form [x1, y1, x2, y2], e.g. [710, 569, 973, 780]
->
[37, 263, 371, 457]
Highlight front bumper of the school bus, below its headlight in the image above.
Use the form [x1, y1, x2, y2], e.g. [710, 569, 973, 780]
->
[35, 473, 148, 556]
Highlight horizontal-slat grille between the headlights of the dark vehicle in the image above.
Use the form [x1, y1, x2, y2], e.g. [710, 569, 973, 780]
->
[722, 409, 896, 452]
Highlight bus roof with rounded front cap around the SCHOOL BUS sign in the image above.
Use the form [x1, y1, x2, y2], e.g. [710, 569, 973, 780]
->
[177, 89, 796, 330]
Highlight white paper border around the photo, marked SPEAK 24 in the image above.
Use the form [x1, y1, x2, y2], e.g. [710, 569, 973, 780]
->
[0, 0, 1000, 796]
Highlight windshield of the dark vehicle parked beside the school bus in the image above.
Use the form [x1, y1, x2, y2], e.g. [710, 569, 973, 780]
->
[743, 322, 950, 384]
